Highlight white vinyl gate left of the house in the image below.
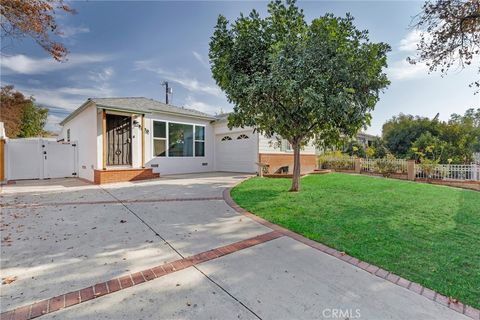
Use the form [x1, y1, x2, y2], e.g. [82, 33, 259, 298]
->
[5, 138, 77, 180]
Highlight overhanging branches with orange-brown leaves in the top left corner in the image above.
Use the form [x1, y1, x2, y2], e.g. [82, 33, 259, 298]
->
[0, 0, 74, 61]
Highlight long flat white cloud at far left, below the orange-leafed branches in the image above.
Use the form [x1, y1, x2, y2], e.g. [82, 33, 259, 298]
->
[0, 54, 110, 75]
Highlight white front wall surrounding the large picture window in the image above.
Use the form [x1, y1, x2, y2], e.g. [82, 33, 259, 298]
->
[144, 113, 215, 175]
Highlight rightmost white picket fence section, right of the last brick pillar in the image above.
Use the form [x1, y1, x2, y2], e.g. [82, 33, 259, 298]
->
[415, 163, 480, 181]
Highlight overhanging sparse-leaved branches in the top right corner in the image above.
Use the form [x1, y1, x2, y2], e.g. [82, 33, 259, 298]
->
[410, 0, 480, 89]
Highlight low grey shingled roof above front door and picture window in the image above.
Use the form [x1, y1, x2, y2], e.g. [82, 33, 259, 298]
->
[60, 97, 216, 125]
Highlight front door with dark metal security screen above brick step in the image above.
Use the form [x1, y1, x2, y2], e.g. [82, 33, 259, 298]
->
[106, 114, 132, 166]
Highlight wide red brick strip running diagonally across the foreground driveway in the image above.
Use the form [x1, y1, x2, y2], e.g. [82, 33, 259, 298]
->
[0, 231, 283, 320]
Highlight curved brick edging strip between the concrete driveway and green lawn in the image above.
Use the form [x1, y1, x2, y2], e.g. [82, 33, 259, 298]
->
[223, 188, 480, 320]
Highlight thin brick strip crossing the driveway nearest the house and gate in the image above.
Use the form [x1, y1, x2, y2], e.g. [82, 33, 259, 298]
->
[0, 197, 223, 209]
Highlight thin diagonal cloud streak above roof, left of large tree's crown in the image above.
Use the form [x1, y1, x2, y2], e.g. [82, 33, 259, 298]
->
[134, 60, 222, 97]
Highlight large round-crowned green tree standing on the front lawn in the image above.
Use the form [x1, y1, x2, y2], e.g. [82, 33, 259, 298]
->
[209, 0, 390, 191]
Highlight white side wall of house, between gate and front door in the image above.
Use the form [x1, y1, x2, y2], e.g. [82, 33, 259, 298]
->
[59, 103, 97, 181]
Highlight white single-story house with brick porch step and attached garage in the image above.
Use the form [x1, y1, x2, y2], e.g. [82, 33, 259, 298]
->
[59, 97, 316, 183]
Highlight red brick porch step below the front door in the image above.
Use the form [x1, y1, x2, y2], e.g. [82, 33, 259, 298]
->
[94, 168, 160, 184]
